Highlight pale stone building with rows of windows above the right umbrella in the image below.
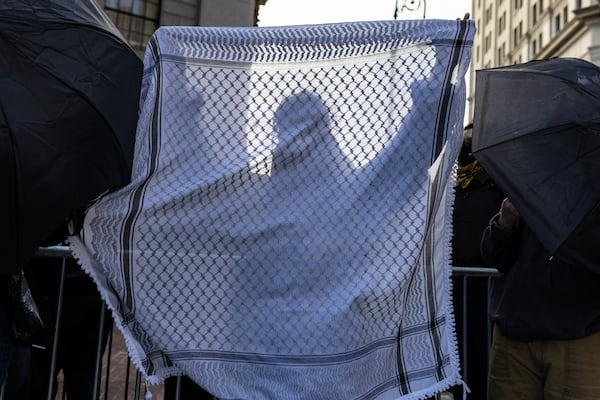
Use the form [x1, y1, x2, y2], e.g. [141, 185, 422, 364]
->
[467, 0, 600, 117]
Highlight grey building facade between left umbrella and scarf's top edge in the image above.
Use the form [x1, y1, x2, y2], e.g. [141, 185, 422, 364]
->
[96, 0, 267, 55]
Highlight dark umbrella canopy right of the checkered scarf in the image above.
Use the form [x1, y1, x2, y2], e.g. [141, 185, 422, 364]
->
[473, 58, 600, 269]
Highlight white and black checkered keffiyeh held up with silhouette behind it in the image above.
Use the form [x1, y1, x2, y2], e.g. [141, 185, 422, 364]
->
[71, 20, 474, 400]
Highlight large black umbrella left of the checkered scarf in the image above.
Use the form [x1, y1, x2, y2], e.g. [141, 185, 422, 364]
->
[0, 0, 142, 272]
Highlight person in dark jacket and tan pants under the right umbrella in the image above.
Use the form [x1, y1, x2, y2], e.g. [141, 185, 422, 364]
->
[481, 199, 600, 400]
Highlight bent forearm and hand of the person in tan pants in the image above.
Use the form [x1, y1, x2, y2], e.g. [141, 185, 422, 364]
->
[480, 199, 522, 272]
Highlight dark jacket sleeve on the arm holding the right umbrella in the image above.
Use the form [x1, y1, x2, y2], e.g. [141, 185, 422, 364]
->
[480, 214, 522, 272]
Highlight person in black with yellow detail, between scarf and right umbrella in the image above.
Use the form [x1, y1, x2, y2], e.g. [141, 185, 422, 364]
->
[452, 123, 504, 400]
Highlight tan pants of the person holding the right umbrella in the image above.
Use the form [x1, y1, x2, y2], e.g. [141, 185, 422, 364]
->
[488, 327, 600, 400]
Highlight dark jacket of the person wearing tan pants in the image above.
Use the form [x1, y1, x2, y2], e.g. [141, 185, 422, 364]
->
[481, 215, 600, 341]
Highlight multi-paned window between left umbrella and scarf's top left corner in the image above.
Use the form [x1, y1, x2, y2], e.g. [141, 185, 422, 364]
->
[104, 0, 161, 50]
